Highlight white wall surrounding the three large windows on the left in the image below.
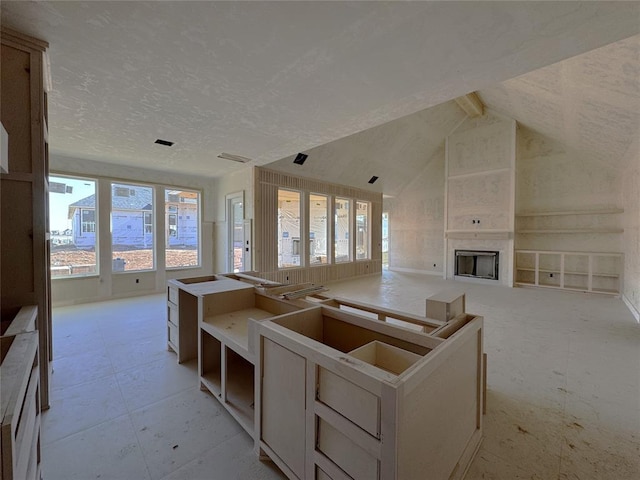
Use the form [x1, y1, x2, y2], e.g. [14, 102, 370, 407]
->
[50, 155, 217, 305]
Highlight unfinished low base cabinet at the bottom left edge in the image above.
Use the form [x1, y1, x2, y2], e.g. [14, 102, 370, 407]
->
[0, 306, 41, 480]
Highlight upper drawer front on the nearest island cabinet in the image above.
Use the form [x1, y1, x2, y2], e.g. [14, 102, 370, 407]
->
[318, 368, 380, 438]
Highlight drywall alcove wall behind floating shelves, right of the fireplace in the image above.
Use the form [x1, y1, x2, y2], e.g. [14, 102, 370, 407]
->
[516, 126, 623, 252]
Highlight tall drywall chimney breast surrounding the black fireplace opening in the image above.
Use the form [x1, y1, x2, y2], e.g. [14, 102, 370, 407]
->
[445, 110, 516, 286]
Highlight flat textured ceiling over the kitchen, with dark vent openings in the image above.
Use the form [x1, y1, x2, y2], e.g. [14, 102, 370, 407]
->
[0, 0, 640, 188]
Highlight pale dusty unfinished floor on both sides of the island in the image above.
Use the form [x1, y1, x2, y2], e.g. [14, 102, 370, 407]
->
[42, 271, 640, 480]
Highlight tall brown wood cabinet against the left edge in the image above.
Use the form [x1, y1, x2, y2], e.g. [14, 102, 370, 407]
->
[0, 28, 51, 408]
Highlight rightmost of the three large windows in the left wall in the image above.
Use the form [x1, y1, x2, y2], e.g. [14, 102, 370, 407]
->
[164, 188, 200, 268]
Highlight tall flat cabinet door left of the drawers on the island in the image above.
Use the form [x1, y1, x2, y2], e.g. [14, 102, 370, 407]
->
[261, 338, 306, 478]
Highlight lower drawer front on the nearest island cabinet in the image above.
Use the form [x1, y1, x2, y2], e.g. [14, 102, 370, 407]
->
[316, 418, 379, 480]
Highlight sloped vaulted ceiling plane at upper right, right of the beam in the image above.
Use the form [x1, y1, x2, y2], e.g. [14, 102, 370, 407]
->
[479, 35, 640, 168]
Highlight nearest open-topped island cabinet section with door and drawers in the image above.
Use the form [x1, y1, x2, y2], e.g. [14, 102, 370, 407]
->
[253, 305, 483, 480]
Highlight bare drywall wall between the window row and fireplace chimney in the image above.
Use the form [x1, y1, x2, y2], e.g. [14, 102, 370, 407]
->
[384, 142, 445, 275]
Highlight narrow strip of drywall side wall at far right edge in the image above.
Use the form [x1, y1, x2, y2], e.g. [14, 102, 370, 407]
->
[622, 144, 640, 322]
